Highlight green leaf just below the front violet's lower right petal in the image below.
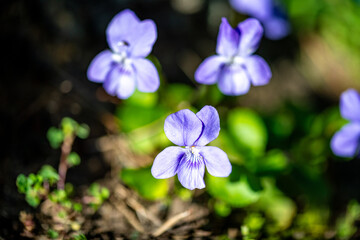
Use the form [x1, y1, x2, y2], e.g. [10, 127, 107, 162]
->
[207, 164, 262, 207]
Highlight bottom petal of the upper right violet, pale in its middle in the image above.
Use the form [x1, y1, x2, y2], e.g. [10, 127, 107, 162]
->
[218, 66, 250, 96]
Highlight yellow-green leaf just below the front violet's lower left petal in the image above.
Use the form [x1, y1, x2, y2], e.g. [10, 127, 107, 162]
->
[120, 168, 169, 200]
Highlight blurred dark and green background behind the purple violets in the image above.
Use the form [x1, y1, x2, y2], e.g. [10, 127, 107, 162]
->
[0, 0, 360, 239]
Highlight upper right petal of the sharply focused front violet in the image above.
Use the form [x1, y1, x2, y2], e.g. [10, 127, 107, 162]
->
[195, 106, 220, 146]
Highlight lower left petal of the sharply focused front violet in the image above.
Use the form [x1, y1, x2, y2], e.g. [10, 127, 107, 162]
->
[151, 147, 185, 179]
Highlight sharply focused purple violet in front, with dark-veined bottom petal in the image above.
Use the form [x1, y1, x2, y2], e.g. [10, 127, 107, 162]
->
[151, 106, 231, 190]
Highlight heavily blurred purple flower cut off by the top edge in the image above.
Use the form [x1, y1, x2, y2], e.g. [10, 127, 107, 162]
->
[230, 0, 290, 40]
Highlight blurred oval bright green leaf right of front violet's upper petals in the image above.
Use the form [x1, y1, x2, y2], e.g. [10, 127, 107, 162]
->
[228, 108, 267, 153]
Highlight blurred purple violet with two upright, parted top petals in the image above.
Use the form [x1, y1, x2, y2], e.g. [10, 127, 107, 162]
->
[195, 18, 271, 96]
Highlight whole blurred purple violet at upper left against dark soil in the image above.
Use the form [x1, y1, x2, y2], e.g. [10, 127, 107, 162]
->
[87, 9, 160, 99]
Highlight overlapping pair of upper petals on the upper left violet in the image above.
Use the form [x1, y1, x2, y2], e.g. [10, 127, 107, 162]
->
[106, 9, 157, 57]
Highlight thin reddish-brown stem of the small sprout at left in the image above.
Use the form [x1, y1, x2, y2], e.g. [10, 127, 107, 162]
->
[57, 134, 75, 189]
